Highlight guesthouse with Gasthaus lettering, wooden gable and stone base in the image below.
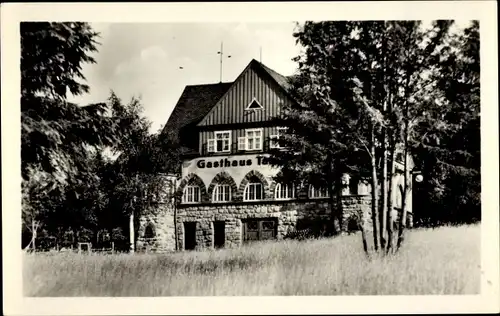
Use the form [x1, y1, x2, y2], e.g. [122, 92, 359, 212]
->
[137, 60, 411, 251]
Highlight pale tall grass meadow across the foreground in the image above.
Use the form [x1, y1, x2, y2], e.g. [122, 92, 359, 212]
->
[23, 225, 480, 296]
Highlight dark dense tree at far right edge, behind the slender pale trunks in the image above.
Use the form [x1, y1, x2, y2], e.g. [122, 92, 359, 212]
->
[412, 21, 481, 223]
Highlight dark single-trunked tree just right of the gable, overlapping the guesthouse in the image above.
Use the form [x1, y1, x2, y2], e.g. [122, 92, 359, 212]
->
[272, 22, 376, 234]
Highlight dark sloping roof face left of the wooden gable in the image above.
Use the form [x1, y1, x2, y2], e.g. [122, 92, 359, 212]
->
[163, 82, 232, 138]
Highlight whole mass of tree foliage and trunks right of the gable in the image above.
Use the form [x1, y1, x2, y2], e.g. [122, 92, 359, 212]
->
[273, 21, 479, 250]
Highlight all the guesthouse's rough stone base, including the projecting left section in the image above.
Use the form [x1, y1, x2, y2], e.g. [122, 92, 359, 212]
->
[137, 195, 412, 252]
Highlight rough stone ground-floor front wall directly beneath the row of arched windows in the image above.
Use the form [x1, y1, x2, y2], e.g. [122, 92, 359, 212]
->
[177, 195, 371, 250]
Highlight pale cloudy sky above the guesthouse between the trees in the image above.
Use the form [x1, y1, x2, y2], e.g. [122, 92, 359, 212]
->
[70, 22, 300, 132]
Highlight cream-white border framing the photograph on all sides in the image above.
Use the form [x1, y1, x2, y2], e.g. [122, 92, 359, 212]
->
[1, 1, 499, 315]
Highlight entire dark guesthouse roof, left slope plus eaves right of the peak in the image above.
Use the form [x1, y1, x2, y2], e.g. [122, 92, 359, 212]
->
[162, 59, 290, 139]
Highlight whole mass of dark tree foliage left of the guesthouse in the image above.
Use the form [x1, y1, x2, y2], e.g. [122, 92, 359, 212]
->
[21, 22, 182, 248]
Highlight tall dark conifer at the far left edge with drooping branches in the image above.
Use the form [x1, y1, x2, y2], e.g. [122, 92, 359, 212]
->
[21, 22, 120, 249]
